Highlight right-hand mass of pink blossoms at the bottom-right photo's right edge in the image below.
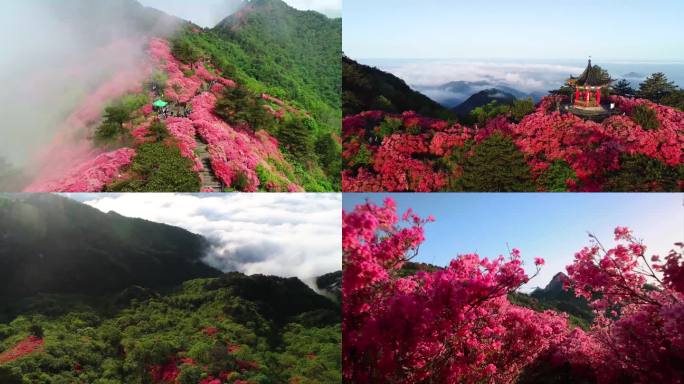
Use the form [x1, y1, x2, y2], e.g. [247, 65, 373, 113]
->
[556, 227, 684, 383]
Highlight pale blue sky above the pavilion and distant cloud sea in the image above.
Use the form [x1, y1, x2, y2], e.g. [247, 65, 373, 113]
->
[342, 0, 684, 60]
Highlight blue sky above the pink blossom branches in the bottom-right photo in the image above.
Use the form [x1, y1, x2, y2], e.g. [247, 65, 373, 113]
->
[343, 193, 684, 290]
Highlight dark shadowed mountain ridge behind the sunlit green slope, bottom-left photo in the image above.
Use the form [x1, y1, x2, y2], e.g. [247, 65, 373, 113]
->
[0, 194, 220, 298]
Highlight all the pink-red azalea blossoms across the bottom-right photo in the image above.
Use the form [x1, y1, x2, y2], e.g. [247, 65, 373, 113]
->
[342, 199, 684, 384]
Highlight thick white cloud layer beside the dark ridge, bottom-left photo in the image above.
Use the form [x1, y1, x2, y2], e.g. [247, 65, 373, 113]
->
[81, 193, 342, 278]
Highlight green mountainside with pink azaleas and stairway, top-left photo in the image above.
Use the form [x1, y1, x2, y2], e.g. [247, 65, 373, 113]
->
[10, 0, 341, 192]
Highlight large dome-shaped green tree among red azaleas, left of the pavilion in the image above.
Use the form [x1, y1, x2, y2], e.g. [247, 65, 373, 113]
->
[456, 133, 535, 192]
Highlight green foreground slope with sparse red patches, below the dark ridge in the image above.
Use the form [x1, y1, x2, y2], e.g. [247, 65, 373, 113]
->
[0, 273, 342, 384]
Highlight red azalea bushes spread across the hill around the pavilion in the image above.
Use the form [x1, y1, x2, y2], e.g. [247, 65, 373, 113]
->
[342, 96, 684, 192]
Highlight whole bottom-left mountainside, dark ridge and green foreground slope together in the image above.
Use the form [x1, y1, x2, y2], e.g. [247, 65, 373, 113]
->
[0, 194, 342, 384]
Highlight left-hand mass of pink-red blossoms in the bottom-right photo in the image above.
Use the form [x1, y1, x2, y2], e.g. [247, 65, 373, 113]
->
[342, 199, 567, 383]
